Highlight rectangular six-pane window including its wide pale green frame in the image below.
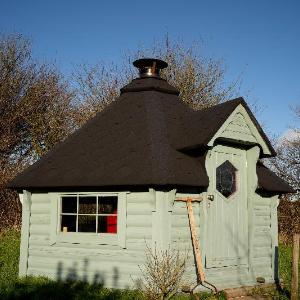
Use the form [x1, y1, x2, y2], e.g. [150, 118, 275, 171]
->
[49, 192, 129, 248]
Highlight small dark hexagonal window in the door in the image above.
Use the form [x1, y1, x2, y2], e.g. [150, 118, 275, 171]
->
[216, 160, 237, 198]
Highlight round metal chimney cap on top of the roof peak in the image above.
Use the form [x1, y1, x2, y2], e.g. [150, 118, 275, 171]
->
[133, 58, 168, 78]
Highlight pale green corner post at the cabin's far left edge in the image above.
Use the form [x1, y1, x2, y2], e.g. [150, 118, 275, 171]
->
[19, 190, 31, 276]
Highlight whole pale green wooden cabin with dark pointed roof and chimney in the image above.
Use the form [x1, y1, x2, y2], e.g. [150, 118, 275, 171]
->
[10, 59, 292, 289]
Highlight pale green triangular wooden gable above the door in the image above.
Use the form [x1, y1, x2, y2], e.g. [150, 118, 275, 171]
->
[208, 104, 272, 156]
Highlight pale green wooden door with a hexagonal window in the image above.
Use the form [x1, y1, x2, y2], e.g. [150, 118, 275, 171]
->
[205, 145, 248, 268]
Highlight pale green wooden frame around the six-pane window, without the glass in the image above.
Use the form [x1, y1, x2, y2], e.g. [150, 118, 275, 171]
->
[49, 192, 127, 248]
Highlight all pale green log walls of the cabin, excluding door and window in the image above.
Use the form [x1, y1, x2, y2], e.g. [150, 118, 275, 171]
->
[20, 178, 278, 288]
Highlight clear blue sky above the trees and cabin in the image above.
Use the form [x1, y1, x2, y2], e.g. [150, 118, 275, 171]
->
[0, 0, 300, 135]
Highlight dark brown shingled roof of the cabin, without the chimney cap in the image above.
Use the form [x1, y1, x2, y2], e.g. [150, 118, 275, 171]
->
[9, 60, 292, 191]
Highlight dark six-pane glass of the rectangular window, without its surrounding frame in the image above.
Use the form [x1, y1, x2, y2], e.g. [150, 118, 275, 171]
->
[60, 195, 118, 236]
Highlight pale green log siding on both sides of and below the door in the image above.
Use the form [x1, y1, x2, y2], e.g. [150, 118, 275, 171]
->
[171, 194, 277, 289]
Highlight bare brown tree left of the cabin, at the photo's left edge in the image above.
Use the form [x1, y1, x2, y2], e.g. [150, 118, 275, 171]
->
[0, 34, 72, 229]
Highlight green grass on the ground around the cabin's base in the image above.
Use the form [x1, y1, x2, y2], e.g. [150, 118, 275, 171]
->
[0, 230, 292, 300]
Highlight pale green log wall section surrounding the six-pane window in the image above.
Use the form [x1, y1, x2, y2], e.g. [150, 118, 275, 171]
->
[24, 193, 153, 288]
